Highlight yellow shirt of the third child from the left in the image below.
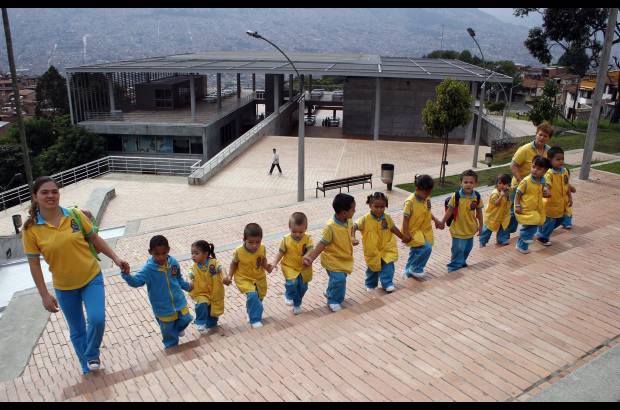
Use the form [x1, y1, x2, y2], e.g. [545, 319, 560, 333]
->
[233, 244, 267, 300]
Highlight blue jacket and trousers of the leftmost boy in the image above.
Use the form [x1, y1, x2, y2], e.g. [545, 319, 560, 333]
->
[121, 256, 193, 348]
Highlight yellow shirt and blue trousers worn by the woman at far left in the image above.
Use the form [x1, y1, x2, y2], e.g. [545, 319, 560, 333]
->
[22, 207, 105, 373]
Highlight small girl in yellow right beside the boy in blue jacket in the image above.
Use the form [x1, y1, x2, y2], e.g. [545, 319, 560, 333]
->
[189, 240, 227, 332]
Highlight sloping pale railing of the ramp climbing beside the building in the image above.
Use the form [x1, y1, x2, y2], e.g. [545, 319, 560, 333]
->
[188, 99, 296, 184]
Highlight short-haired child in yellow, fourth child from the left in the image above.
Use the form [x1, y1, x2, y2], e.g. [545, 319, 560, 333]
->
[272, 212, 314, 315]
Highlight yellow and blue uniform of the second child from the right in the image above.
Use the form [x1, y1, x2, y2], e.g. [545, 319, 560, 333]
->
[514, 174, 546, 250]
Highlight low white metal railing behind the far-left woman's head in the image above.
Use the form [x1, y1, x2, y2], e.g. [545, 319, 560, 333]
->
[0, 156, 201, 210]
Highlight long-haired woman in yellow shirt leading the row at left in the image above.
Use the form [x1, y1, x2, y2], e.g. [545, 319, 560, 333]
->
[22, 176, 129, 374]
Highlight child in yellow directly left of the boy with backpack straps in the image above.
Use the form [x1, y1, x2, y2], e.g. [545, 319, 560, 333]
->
[402, 175, 444, 280]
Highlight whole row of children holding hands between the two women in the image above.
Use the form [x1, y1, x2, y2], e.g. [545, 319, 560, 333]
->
[122, 121, 575, 348]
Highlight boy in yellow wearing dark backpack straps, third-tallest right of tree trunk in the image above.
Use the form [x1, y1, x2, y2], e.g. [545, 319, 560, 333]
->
[441, 169, 484, 272]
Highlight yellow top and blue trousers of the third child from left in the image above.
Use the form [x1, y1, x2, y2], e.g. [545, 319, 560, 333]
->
[233, 244, 267, 324]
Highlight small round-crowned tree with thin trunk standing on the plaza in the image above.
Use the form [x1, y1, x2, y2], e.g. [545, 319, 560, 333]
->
[422, 78, 473, 185]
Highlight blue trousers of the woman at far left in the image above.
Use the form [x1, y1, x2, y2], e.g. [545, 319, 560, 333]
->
[54, 272, 105, 374]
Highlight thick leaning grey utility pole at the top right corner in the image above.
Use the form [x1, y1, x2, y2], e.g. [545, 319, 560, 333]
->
[577, 7, 618, 180]
